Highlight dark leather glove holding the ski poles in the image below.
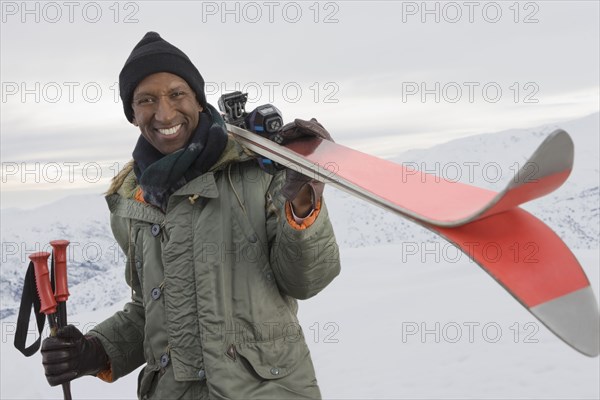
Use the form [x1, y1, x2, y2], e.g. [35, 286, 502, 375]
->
[42, 325, 109, 386]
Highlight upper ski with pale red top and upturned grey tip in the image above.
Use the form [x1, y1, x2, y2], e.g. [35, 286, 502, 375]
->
[228, 125, 574, 227]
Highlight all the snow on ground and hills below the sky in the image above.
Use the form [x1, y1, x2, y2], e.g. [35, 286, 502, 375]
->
[0, 114, 600, 399]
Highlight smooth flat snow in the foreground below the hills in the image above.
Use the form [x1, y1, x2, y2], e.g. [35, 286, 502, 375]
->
[0, 245, 600, 399]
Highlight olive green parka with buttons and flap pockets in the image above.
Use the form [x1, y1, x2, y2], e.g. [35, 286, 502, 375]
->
[90, 137, 340, 399]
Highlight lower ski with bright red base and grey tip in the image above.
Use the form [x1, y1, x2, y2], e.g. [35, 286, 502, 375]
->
[432, 207, 600, 357]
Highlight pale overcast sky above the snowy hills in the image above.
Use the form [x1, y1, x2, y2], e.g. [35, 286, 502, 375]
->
[0, 1, 600, 208]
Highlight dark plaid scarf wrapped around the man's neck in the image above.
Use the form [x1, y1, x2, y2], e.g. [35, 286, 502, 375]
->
[133, 104, 227, 212]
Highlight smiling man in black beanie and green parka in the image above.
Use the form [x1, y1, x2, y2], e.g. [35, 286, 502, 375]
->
[42, 32, 340, 399]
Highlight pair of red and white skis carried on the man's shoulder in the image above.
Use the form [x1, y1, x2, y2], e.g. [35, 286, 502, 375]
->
[227, 125, 600, 356]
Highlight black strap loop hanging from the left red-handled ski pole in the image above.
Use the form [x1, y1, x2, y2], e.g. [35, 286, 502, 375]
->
[14, 261, 45, 357]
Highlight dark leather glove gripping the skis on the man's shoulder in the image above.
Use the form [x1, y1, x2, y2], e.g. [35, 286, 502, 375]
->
[271, 118, 333, 203]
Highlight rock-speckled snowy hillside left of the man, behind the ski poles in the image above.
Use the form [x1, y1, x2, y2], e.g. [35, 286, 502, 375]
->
[0, 195, 128, 318]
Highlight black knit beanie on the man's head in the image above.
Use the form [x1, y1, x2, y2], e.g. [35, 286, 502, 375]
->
[119, 32, 206, 122]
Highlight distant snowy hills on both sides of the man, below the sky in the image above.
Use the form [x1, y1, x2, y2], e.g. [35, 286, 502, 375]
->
[0, 114, 600, 318]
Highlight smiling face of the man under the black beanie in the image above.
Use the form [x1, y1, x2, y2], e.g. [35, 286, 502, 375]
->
[132, 72, 202, 154]
